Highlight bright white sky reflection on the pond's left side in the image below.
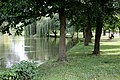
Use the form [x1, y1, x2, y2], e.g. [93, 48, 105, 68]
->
[0, 34, 28, 67]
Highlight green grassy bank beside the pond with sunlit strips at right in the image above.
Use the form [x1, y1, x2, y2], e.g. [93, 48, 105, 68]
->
[36, 38, 120, 80]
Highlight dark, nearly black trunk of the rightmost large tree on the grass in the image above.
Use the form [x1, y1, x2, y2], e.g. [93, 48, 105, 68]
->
[93, 15, 103, 56]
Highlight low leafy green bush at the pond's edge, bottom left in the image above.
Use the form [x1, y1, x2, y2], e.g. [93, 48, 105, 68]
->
[0, 61, 37, 80]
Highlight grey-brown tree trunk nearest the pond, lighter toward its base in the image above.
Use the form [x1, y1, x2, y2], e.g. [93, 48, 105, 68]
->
[58, 8, 67, 62]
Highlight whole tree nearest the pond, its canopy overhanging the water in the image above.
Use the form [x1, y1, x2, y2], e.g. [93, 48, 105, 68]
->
[0, 0, 84, 61]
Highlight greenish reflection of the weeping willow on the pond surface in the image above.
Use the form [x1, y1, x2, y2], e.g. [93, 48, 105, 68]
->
[24, 38, 58, 62]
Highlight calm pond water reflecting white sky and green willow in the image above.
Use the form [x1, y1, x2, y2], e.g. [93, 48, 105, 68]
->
[0, 34, 73, 68]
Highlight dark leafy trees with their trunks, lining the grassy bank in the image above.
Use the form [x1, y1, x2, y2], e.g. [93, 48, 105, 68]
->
[0, 0, 119, 61]
